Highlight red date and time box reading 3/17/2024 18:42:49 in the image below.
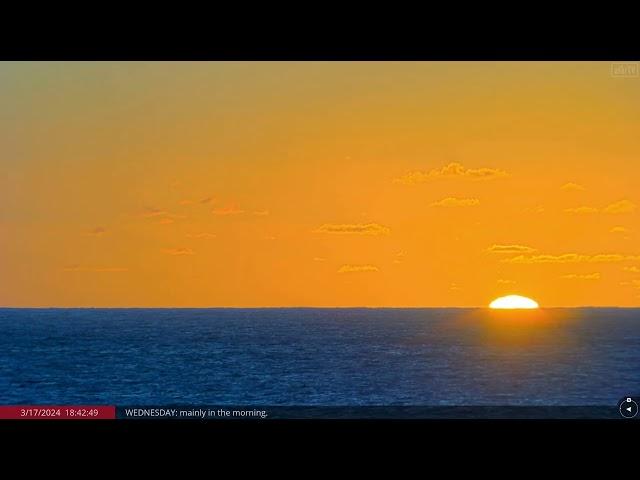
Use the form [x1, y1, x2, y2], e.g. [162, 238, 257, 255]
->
[0, 405, 116, 420]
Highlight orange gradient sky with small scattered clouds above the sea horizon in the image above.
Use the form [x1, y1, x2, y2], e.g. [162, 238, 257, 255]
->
[0, 62, 640, 306]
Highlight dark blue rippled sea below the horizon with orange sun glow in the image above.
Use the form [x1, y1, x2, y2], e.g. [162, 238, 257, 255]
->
[0, 309, 640, 405]
